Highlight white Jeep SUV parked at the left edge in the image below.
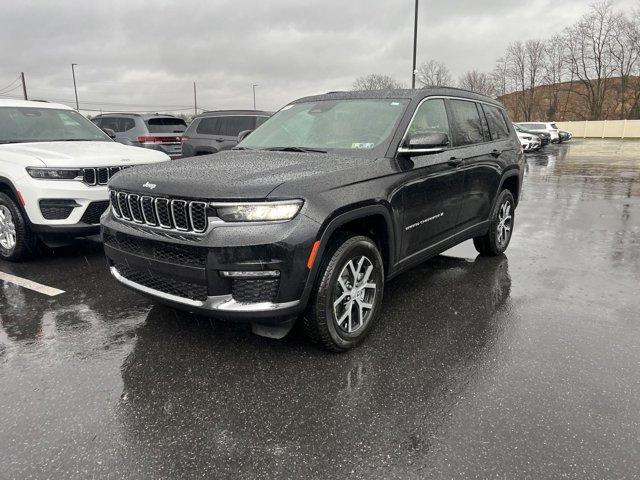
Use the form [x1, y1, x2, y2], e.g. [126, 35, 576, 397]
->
[0, 100, 169, 261]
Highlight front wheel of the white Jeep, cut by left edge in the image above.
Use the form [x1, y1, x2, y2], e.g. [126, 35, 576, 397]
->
[0, 193, 37, 262]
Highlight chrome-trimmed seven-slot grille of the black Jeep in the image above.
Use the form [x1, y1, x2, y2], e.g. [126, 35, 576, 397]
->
[109, 190, 208, 233]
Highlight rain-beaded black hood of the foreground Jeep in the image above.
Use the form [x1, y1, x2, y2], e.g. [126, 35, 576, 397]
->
[109, 150, 373, 200]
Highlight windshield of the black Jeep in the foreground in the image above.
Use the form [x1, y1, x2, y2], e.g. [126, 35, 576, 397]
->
[237, 99, 407, 156]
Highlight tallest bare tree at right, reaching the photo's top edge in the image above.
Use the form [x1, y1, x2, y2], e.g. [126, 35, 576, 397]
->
[566, 0, 616, 120]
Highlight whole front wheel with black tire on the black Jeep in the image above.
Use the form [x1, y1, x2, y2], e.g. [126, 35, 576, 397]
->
[302, 235, 384, 352]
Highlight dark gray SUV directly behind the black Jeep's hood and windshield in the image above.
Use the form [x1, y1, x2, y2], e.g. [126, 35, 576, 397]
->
[182, 110, 271, 157]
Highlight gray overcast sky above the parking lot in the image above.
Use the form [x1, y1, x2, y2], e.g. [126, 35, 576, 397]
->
[0, 0, 637, 111]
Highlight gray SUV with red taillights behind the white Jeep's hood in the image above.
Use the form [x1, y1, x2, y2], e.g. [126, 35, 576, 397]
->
[91, 113, 187, 158]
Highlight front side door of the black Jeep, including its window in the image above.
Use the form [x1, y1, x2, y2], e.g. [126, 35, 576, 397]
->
[398, 98, 464, 258]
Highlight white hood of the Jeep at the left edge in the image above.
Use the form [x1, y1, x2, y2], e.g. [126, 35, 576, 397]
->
[0, 142, 169, 167]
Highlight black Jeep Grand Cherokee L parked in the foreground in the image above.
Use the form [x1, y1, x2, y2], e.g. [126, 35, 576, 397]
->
[102, 88, 524, 351]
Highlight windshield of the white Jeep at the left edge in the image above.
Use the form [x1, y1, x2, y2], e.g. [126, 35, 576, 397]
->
[0, 107, 111, 143]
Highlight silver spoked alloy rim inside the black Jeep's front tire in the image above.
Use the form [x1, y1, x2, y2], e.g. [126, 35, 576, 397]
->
[333, 255, 378, 334]
